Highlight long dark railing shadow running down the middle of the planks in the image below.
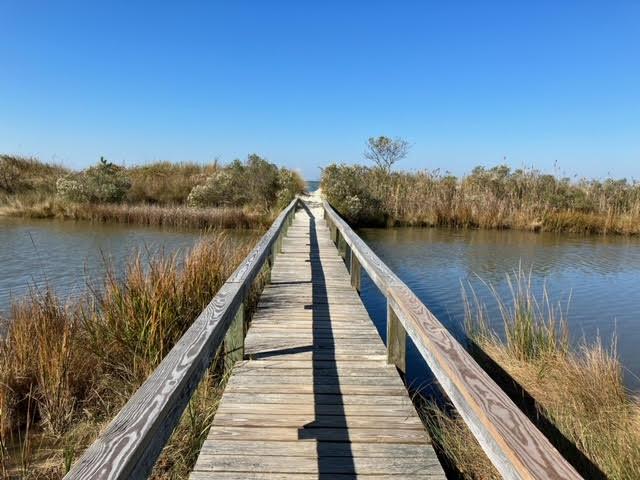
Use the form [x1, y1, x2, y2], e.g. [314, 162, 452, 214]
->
[298, 205, 356, 479]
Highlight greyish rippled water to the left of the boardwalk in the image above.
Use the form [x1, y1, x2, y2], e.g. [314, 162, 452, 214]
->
[0, 218, 208, 315]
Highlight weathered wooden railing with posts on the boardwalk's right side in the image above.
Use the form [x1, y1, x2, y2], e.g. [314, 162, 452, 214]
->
[323, 201, 582, 479]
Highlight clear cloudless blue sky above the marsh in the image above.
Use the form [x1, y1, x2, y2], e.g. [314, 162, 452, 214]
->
[0, 0, 640, 179]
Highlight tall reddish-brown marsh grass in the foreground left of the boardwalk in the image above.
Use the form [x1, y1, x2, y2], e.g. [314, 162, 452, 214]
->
[0, 232, 262, 478]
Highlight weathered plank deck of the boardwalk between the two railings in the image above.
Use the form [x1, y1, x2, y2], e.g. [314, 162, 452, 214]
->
[191, 199, 445, 480]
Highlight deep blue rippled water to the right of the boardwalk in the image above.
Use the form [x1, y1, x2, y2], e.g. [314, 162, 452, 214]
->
[360, 228, 640, 390]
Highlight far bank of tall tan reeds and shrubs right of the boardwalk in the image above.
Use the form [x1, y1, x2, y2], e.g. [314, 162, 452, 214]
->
[322, 164, 640, 234]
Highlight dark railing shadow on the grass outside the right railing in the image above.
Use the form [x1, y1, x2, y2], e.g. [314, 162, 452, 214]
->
[467, 338, 607, 480]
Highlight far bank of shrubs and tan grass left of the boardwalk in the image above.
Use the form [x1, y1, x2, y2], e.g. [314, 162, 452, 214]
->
[0, 155, 305, 228]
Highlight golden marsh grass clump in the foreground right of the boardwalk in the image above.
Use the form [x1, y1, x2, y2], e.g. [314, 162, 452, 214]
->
[423, 272, 640, 480]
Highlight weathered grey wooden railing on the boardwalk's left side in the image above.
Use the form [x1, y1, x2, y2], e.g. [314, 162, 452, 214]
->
[65, 198, 298, 480]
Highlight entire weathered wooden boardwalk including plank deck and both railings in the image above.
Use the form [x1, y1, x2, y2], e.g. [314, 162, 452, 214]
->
[70, 192, 582, 480]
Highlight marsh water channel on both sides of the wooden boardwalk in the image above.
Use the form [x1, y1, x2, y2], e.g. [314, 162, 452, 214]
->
[0, 218, 640, 391]
